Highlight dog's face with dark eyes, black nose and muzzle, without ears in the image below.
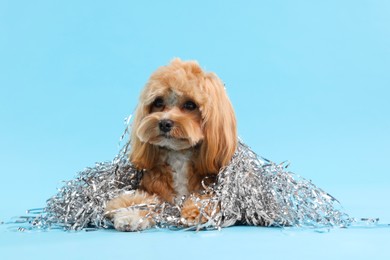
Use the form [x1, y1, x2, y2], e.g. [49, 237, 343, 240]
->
[136, 74, 206, 150]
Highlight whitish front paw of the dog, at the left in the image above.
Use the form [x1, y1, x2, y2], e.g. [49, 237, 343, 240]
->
[112, 209, 154, 231]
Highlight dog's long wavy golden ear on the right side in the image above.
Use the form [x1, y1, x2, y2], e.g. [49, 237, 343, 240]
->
[198, 73, 238, 174]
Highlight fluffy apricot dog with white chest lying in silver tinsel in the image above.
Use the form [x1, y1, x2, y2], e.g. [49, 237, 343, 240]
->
[106, 59, 238, 231]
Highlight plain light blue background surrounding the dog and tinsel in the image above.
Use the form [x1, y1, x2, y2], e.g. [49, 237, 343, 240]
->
[0, 0, 390, 259]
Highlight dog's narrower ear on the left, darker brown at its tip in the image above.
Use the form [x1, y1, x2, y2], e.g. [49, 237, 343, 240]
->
[129, 100, 158, 169]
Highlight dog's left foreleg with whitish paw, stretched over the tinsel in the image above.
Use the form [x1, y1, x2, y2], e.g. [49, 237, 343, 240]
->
[105, 190, 159, 231]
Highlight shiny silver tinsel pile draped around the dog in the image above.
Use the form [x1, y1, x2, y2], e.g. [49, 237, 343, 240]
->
[9, 134, 353, 230]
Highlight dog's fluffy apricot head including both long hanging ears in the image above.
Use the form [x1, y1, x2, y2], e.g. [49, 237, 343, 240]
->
[130, 59, 237, 174]
